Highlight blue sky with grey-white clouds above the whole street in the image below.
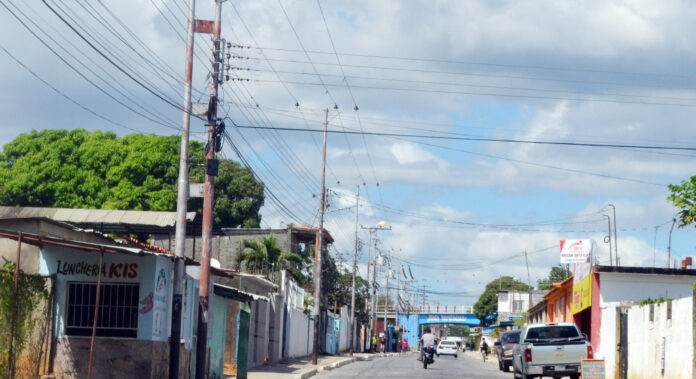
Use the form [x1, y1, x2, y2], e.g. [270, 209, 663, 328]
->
[0, 0, 696, 305]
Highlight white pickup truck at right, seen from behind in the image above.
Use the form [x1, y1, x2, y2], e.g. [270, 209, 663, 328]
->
[512, 323, 593, 379]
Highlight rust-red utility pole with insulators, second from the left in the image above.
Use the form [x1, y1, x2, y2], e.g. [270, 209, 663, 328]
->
[196, 0, 224, 379]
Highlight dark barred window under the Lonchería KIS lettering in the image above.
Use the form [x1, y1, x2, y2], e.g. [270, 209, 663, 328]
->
[65, 282, 140, 338]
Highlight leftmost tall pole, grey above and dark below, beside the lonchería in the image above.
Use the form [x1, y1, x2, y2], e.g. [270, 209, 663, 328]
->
[169, 0, 196, 379]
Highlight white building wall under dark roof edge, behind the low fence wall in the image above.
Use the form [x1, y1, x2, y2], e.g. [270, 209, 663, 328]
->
[595, 272, 696, 378]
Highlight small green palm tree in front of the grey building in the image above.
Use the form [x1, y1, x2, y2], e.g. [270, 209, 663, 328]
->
[237, 235, 303, 276]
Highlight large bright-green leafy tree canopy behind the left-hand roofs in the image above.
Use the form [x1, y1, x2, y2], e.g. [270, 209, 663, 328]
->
[0, 129, 264, 227]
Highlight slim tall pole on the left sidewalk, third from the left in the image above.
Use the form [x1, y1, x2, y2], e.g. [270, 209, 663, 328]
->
[312, 109, 329, 365]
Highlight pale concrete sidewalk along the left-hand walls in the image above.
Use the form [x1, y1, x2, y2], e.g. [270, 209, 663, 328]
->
[232, 353, 402, 379]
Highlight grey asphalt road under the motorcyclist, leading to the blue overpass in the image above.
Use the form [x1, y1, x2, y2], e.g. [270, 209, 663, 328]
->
[317, 353, 513, 379]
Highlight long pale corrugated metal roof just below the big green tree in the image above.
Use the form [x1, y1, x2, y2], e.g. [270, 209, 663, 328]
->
[0, 206, 196, 227]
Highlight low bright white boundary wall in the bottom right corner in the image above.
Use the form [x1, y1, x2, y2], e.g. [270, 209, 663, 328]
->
[628, 297, 694, 379]
